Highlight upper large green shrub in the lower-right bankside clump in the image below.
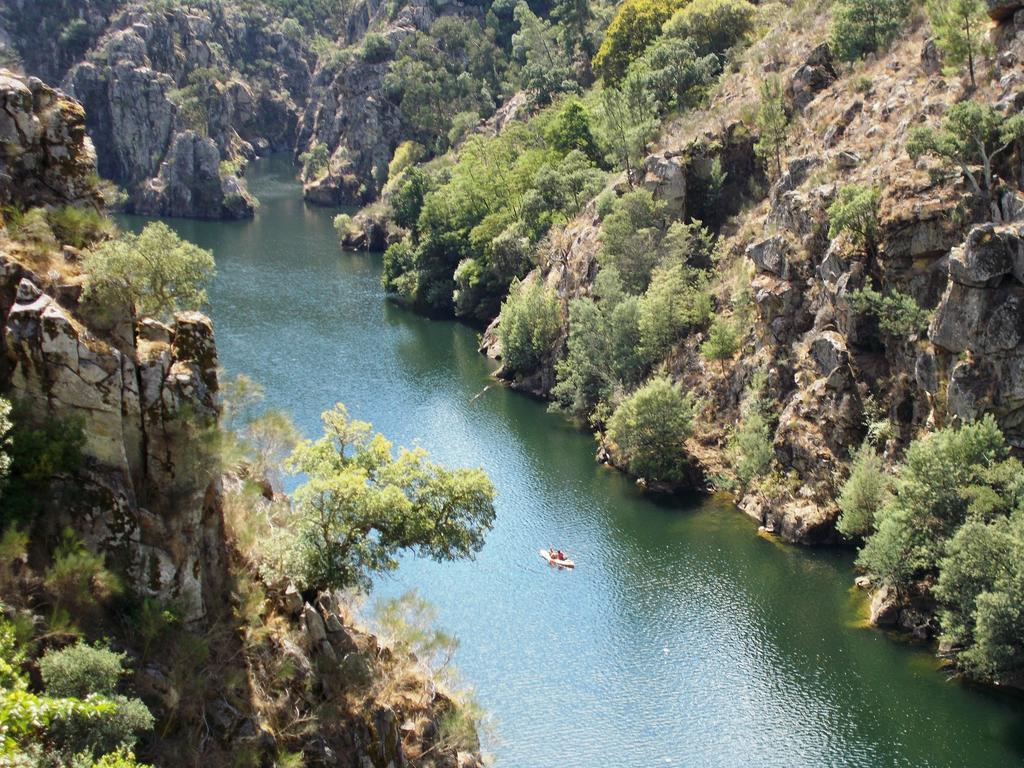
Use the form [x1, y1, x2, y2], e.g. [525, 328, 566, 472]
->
[858, 416, 1024, 588]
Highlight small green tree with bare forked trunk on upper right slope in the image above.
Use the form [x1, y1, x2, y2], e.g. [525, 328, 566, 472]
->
[906, 99, 1024, 222]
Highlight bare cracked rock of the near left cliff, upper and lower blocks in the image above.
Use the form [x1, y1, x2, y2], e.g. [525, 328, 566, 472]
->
[0, 74, 223, 621]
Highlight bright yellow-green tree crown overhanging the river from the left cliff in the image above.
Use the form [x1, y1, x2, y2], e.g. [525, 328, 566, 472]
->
[264, 404, 495, 590]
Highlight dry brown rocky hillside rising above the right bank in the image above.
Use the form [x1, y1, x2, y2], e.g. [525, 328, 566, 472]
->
[481, 3, 1024, 544]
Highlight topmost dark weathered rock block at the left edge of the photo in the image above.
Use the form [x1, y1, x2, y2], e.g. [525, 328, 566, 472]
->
[0, 69, 97, 206]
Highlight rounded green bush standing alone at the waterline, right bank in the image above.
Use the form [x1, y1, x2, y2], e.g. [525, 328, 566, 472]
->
[607, 377, 694, 482]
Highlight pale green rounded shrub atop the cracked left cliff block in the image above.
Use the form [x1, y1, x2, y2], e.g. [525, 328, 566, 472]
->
[82, 221, 214, 318]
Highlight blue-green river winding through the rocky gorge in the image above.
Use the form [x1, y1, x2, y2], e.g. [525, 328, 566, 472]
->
[123, 157, 1024, 768]
